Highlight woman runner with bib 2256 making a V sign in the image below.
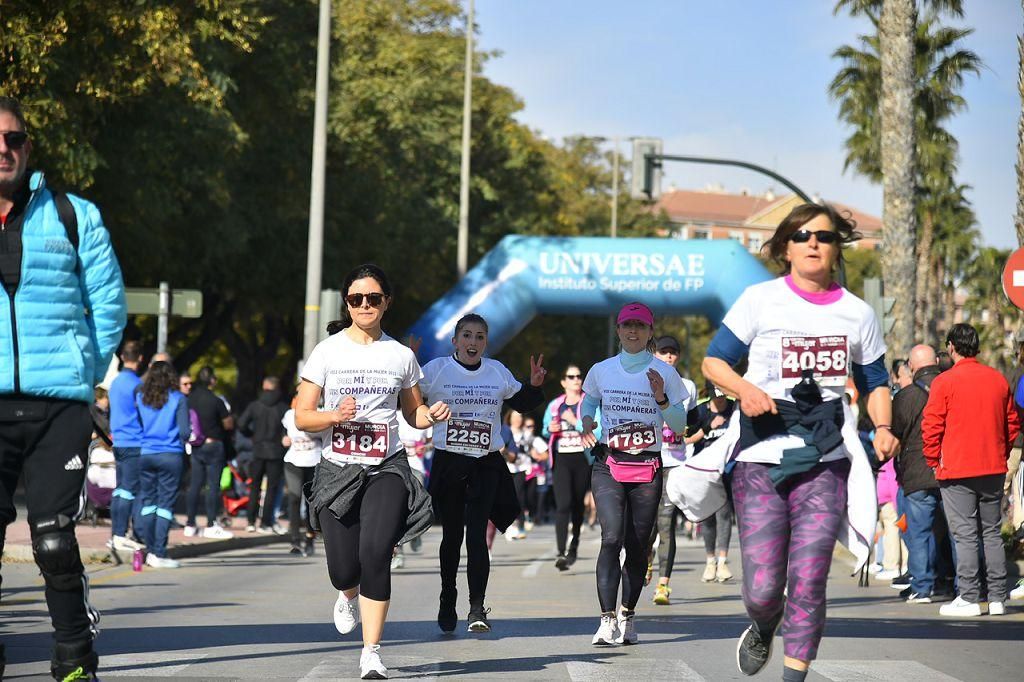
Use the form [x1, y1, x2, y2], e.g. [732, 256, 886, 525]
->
[422, 313, 547, 633]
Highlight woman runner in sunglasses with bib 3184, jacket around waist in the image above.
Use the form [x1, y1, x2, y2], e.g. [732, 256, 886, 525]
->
[295, 264, 450, 680]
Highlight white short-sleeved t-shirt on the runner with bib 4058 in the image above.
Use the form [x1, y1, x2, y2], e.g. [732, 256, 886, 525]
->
[722, 278, 886, 464]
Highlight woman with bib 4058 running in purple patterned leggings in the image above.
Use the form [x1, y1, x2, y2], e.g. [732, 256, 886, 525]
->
[702, 204, 898, 682]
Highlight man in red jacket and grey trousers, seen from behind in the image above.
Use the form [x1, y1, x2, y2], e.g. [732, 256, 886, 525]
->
[921, 324, 1020, 616]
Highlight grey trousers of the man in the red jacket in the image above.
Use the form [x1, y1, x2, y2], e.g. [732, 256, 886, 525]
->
[939, 474, 1007, 603]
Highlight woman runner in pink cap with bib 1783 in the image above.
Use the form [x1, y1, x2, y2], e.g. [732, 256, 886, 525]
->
[581, 303, 689, 646]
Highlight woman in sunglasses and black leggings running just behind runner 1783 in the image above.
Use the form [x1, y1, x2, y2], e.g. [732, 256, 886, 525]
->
[544, 365, 601, 570]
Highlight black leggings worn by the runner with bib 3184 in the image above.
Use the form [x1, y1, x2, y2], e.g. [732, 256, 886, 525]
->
[318, 465, 409, 601]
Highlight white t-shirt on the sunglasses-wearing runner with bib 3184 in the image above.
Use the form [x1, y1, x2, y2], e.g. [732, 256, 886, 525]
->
[302, 331, 423, 466]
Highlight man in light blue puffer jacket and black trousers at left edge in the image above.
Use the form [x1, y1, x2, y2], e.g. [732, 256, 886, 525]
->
[0, 97, 126, 680]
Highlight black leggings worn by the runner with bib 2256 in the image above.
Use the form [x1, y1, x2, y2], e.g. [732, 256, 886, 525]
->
[430, 450, 504, 604]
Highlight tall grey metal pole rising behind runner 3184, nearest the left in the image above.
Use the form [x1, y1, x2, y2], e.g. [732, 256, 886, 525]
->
[302, 0, 331, 359]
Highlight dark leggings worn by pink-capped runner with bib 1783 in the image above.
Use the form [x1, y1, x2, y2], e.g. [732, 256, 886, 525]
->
[592, 454, 662, 613]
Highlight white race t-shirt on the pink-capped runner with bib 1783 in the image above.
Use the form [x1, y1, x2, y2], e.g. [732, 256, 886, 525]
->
[583, 355, 689, 455]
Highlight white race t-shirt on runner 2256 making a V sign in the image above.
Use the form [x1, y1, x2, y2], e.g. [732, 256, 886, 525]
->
[420, 357, 522, 457]
